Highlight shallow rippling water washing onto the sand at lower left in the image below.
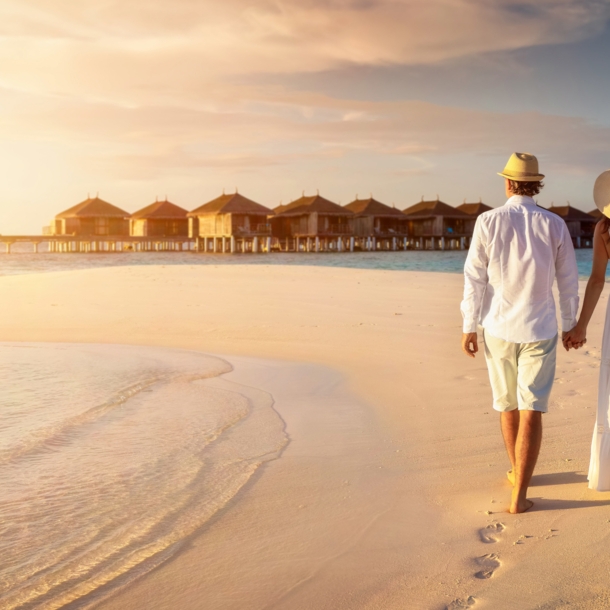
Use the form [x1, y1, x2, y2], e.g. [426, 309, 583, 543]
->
[0, 343, 288, 610]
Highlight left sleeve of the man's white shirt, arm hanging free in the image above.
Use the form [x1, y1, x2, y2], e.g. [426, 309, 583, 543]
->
[460, 216, 489, 333]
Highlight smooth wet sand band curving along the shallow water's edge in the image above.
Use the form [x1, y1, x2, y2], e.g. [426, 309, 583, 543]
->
[95, 354, 414, 610]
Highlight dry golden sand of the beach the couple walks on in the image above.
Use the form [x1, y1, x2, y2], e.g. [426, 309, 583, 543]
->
[0, 265, 610, 610]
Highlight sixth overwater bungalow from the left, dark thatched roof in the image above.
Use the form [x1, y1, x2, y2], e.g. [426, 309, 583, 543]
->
[404, 198, 473, 250]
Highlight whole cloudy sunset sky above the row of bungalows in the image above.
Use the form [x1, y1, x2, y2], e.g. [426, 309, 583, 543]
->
[0, 0, 610, 235]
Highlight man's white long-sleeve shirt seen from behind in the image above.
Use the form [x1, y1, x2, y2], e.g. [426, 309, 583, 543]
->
[461, 195, 578, 343]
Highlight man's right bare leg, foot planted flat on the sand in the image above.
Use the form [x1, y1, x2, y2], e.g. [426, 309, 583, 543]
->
[509, 411, 542, 513]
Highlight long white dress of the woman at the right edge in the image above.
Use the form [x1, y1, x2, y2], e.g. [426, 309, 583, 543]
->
[588, 290, 610, 491]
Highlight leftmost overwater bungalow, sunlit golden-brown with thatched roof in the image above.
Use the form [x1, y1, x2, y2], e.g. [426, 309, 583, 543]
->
[51, 197, 130, 236]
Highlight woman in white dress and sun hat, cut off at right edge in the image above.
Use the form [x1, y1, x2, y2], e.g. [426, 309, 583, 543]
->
[564, 170, 610, 491]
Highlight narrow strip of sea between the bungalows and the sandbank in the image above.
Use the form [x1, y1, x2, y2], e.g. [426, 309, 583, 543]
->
[0, 244, 610, 279]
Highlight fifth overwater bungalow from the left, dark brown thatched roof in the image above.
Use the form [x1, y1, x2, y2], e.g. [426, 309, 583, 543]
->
[345, 196, 407, 250]
